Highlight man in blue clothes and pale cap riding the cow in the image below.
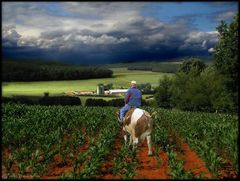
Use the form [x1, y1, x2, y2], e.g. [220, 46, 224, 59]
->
[120, 80, 142, 125]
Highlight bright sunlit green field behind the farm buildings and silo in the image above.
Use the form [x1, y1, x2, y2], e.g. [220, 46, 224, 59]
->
[2, 67, 173, 96]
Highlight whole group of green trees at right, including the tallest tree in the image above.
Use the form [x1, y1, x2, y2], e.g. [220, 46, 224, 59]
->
[155, 14, 239, 112]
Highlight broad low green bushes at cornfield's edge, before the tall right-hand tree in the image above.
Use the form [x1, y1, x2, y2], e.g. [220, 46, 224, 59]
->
[163, 66, 235, 112]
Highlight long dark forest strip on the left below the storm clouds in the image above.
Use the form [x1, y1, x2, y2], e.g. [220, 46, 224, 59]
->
[2, 60, 113, 82]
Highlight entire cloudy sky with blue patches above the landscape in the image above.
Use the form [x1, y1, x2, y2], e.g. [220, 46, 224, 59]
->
[2, 1, 238, 64]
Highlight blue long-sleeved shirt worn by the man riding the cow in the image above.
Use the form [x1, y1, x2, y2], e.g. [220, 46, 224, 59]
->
[124, 87, 142, 107]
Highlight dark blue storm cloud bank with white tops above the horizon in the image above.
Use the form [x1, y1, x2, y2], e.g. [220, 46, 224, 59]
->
[3, 20, 217, 64]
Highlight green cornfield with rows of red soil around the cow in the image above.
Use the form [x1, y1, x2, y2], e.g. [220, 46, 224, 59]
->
[2, 103, 238, 179]
